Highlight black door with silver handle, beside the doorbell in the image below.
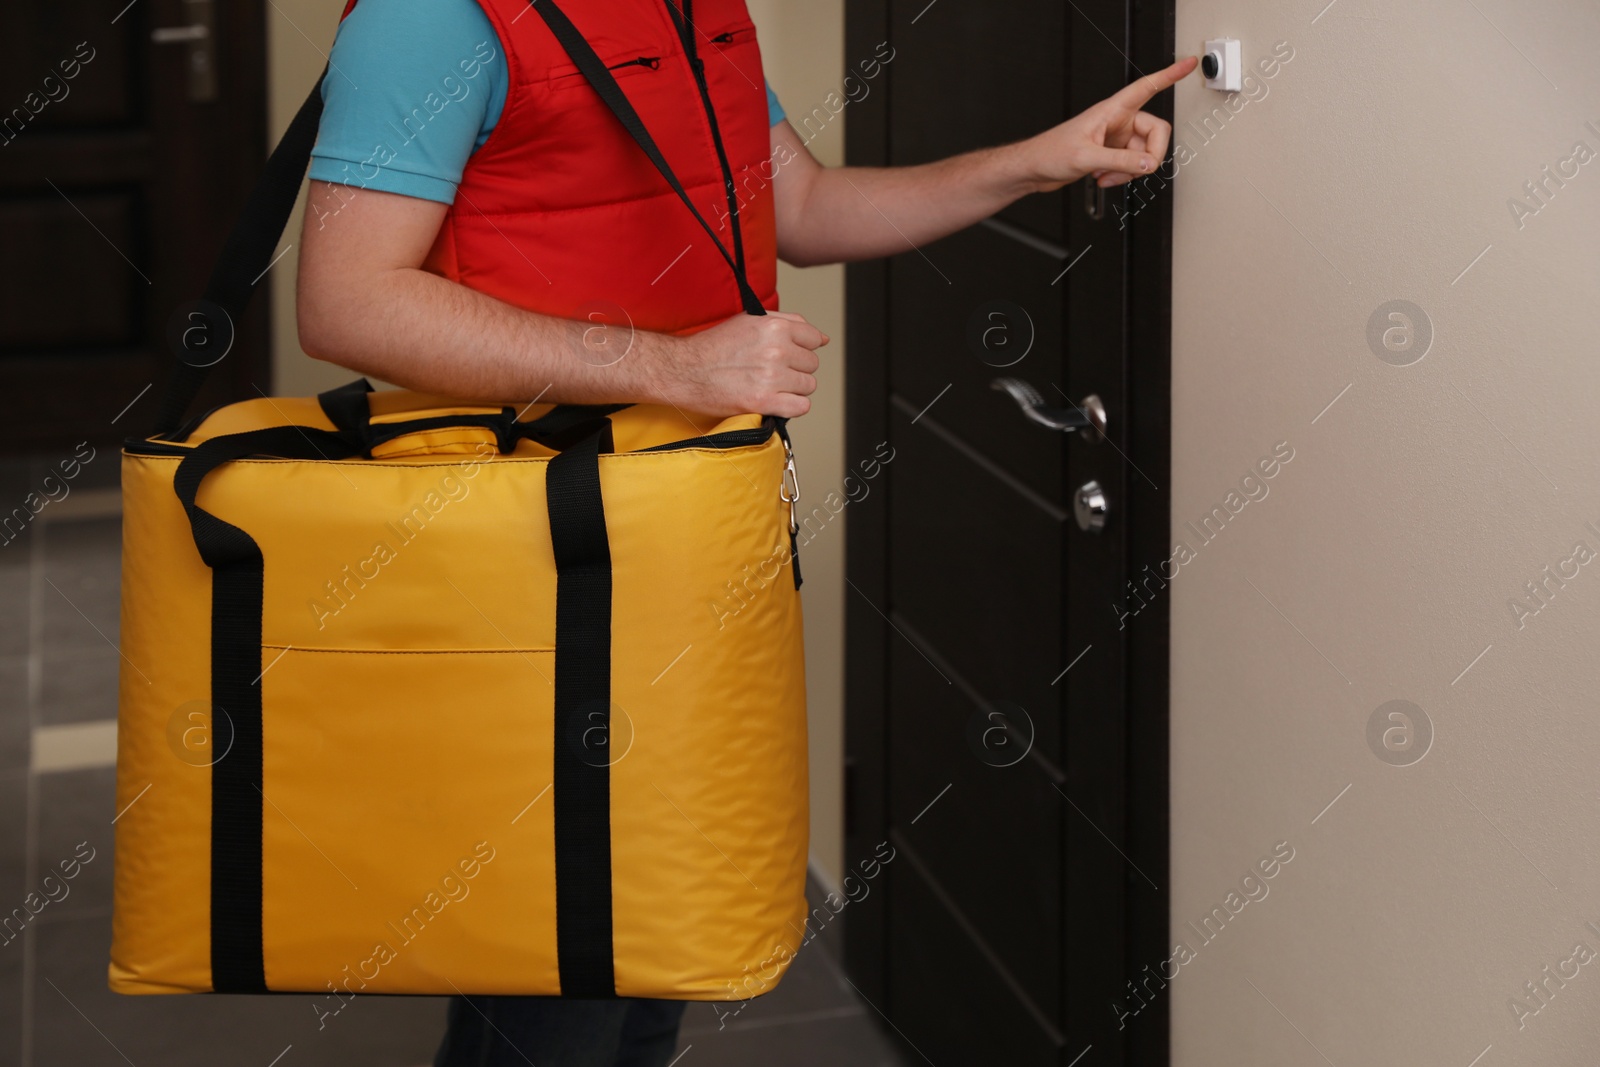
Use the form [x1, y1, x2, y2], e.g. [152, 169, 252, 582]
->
[846, 0, 1173, 1067]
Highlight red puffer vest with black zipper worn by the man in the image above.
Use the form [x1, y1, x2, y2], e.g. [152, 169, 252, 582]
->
[346, 0, 778, 333]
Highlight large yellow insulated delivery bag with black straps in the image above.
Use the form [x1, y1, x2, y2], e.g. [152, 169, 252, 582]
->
[110, 387, 806, 1000]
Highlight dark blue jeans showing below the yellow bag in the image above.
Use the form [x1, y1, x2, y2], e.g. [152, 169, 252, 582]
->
[434, 997, 685, 1067]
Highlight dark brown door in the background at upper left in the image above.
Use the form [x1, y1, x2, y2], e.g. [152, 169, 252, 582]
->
[0, 0, 267, 454]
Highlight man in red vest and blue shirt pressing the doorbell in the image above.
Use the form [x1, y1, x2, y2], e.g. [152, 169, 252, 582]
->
[298, 0, 1195, 1067]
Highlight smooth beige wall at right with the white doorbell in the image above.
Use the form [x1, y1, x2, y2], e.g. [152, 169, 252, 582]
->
[1164, 0, 1600, 1067]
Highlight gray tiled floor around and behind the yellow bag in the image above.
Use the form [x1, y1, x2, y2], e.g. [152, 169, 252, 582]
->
[0, 479, 906, 1067]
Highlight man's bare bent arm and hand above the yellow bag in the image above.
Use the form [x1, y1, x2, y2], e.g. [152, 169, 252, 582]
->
[296, 181, 827, 416]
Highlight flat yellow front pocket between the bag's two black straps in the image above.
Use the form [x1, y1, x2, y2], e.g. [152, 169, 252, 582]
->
[261, 648, 560, 1008]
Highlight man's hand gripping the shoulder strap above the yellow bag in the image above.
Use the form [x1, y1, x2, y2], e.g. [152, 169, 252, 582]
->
[656, 312, 829, 419]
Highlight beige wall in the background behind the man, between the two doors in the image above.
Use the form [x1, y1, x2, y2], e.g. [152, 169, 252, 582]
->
[267, 0, 845, 881]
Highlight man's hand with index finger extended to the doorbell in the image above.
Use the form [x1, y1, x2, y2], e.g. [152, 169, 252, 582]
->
[1018, 56, 1198, 192]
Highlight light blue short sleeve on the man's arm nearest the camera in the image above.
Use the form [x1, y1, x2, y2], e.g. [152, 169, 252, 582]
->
[310, 0, 509, 203]
